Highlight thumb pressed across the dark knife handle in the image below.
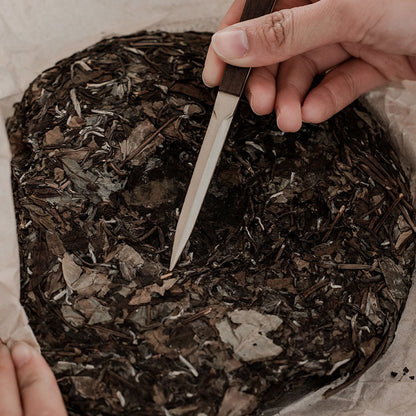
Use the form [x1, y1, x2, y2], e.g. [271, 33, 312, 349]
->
[212, 0, 359, 66]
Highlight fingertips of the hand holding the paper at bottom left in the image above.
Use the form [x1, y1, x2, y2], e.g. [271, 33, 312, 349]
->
[0, 342, 67, 416]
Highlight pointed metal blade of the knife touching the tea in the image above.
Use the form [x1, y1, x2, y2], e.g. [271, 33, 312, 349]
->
[170, 91, 240, 270]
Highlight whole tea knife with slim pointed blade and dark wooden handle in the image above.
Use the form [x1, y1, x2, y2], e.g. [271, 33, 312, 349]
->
[170, 0, 276, 270]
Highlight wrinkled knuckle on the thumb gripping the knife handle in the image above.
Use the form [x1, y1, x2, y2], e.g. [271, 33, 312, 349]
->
[261, 9, 293, 49]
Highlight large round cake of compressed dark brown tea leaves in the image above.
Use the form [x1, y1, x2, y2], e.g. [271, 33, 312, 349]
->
[7, 33, 416, 416]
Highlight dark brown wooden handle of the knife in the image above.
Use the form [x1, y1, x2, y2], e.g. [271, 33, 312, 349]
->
[220, 0, 276, 97]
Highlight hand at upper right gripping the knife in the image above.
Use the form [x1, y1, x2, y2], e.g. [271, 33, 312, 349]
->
[203, 0, 416, 132]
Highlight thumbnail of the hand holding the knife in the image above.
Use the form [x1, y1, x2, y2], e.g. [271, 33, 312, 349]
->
[212, 29, 248, 59]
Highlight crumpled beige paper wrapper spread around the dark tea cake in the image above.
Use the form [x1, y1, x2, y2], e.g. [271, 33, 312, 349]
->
[0, 0, 416, 416]
